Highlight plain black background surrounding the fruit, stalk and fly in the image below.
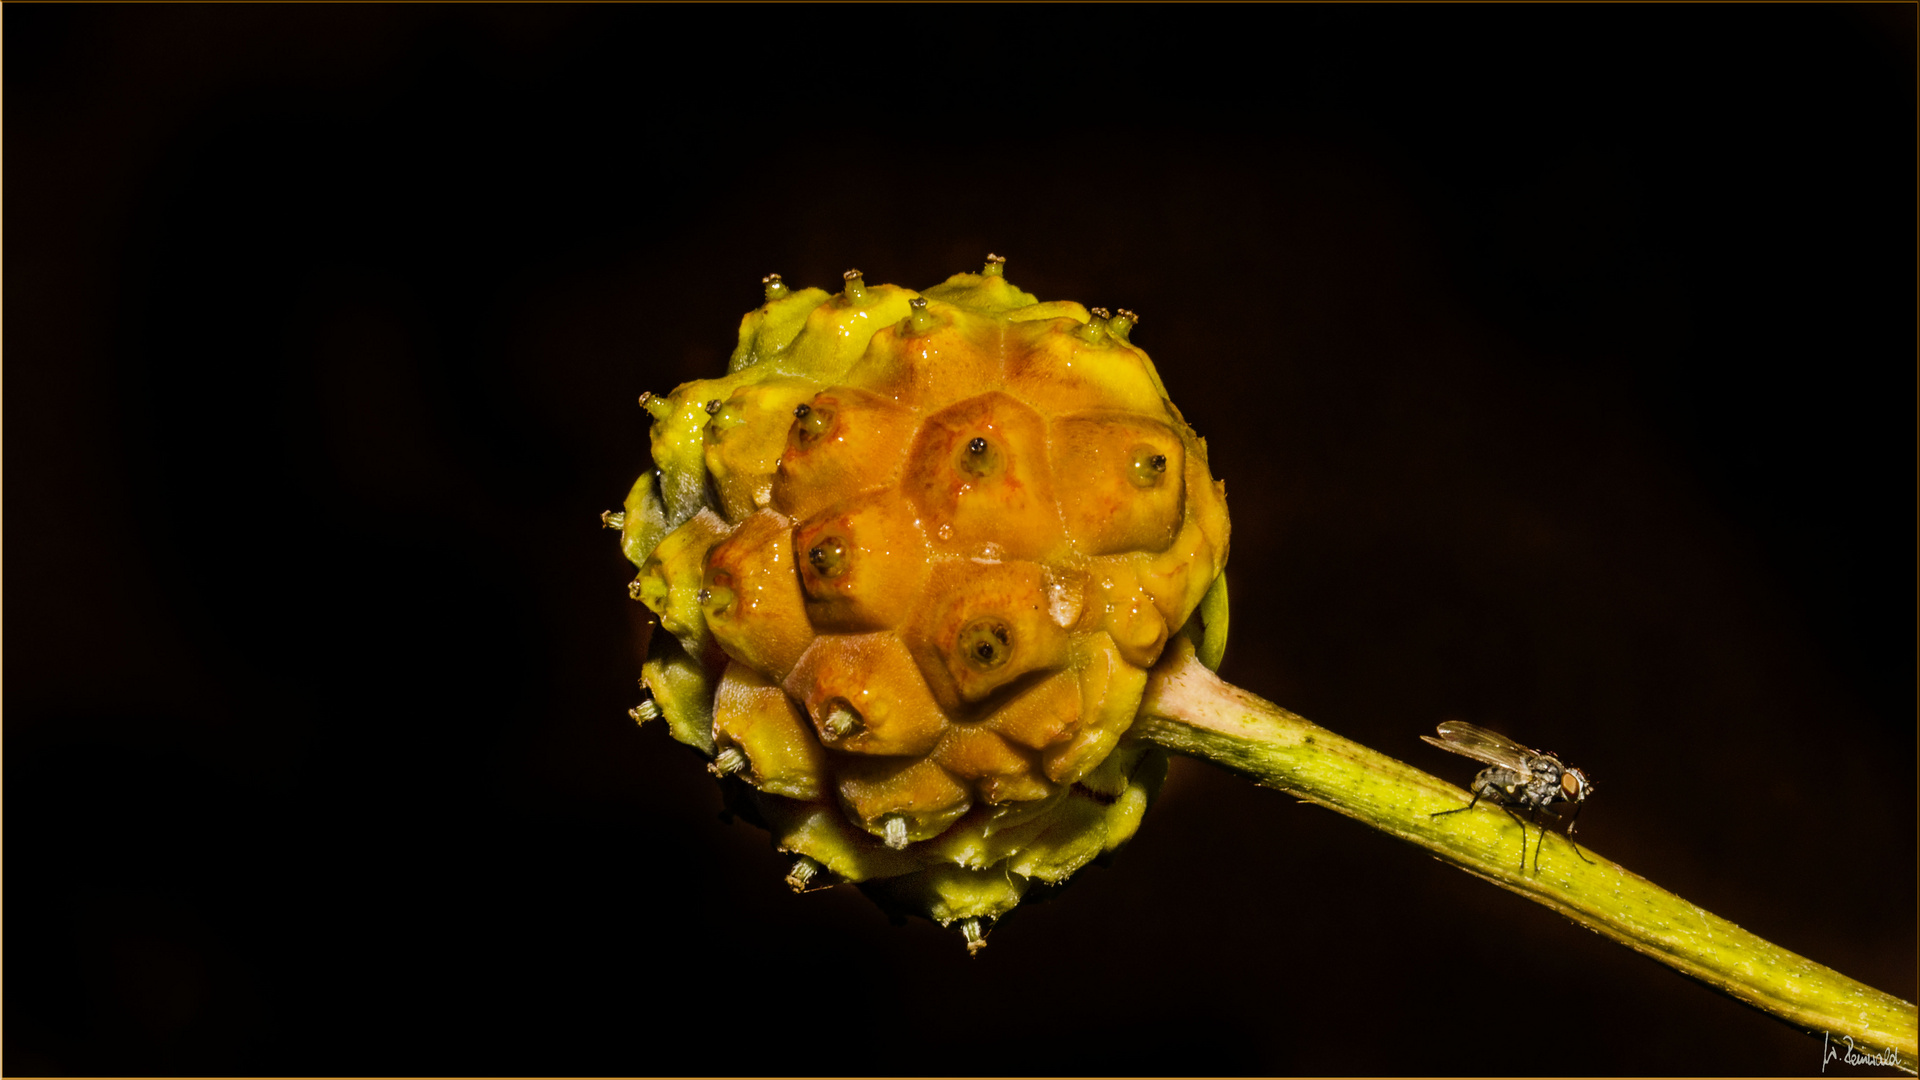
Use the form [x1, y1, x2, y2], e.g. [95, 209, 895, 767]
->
[4, 4, 1916, 1074]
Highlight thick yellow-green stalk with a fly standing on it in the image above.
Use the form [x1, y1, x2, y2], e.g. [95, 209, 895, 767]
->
[1135, 640, 1916, 1072]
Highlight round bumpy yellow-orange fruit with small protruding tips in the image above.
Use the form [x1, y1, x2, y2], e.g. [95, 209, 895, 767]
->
[607, 258, 1227, 949]
